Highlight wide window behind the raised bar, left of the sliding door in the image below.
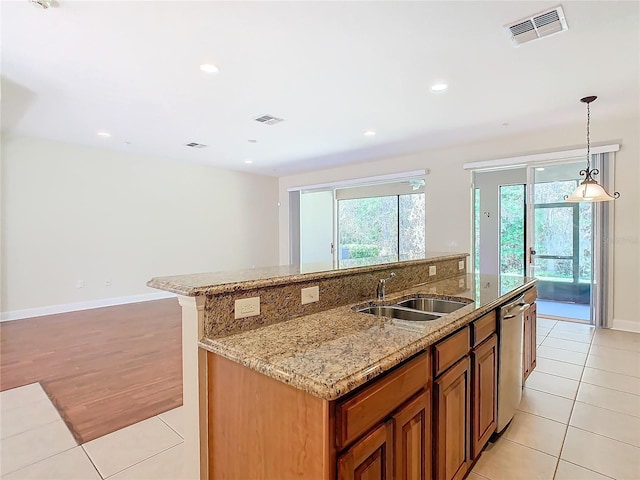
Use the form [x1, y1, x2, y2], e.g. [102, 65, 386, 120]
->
[289, 171, 425, 268]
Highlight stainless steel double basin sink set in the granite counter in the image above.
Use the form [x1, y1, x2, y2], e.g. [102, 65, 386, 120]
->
[356, 296, 468, 322]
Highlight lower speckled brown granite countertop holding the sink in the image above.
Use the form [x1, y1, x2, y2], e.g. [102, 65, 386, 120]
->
[199, 274, 535, 400]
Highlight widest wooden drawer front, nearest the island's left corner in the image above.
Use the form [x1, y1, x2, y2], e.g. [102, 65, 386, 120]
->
[336, 353, 429, 449]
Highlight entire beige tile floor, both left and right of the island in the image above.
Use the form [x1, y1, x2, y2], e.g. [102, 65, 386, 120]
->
[0, 318, 640, 480]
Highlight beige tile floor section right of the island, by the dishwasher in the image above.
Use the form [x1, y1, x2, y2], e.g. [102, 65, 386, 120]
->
[468, 318, 640, 480]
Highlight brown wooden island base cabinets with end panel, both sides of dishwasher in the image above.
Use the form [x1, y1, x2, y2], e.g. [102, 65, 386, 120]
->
[201, 288, 536, 480]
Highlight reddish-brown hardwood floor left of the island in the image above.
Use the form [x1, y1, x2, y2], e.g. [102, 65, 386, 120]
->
[0, 298, 182, 443]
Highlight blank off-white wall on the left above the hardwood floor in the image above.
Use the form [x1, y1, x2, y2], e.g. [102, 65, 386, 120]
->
[1, 138, 278, 317]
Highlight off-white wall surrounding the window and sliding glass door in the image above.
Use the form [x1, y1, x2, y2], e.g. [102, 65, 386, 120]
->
[279, 116, 640, 331]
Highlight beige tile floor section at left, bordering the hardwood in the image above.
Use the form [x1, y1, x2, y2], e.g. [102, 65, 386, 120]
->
[0, 383, 183, 480]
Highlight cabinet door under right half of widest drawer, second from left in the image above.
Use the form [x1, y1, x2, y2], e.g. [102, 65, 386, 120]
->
[393, 390, 431, 480]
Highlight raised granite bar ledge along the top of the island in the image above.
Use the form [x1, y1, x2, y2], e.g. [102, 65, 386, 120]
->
[147, 252, 467, 297]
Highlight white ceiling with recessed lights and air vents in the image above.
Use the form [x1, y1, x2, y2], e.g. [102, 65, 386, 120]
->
[1, 0, 640, 176]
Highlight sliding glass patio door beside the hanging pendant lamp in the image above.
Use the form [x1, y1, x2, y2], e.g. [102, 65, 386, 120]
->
[474, 162, 595, 323]
